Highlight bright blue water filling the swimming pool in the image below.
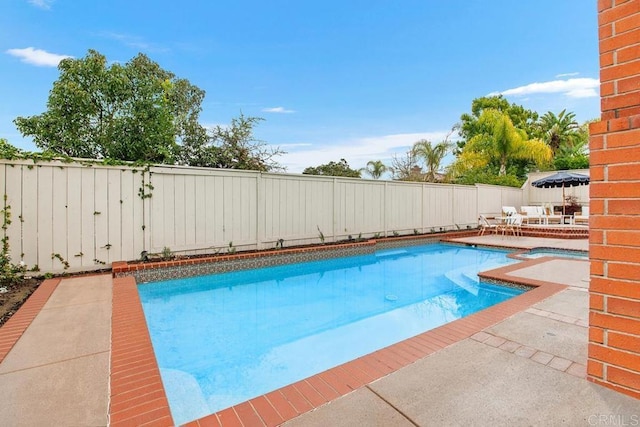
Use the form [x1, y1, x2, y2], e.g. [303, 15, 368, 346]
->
[138, 244, 522, 423]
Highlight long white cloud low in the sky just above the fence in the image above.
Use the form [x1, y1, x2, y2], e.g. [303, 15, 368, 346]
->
[278, 131, 450, 173]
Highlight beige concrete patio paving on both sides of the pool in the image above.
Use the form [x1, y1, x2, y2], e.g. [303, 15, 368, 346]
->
[0, 236, 640, 426]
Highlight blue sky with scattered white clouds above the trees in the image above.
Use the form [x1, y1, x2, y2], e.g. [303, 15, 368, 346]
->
[0, 0, 600, 172]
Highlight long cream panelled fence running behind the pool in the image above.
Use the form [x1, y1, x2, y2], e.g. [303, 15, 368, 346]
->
[0, 160, 522, 272]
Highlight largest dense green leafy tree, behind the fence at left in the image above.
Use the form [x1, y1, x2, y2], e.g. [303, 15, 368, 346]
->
[15, 50, 206, 163]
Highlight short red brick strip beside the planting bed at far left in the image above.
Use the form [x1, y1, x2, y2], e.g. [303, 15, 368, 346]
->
[0, 278, 62, 363]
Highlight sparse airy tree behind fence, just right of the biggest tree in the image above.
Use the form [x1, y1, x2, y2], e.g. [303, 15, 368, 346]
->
[181, 113, 284, 172]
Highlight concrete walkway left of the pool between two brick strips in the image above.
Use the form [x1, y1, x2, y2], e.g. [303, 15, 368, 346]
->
[0, 275, 111, 426]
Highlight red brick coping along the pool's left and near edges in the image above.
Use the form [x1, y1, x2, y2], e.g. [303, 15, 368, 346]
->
[109, 241, 567, 426]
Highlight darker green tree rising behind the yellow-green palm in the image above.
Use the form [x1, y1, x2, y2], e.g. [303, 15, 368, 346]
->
[454, 95, 539, 154]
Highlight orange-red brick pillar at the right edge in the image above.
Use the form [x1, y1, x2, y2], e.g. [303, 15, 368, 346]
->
[587, 0, 640, 398]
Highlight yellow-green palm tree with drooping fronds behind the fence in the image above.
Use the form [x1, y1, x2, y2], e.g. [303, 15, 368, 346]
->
[452, 109, 553, 176]
